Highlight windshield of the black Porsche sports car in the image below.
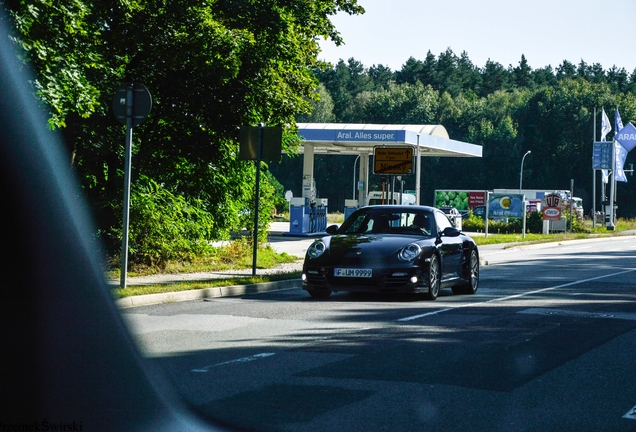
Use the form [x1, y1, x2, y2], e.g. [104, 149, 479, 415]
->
[338, 207, 435, 236]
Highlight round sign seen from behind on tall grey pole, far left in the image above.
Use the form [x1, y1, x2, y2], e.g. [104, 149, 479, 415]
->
[113, 82, 152, 288]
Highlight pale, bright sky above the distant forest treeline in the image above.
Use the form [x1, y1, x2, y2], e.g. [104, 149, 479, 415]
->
[319, 0, 636, 74]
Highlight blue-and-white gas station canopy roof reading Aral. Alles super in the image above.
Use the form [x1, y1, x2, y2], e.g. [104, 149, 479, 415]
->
[298, 123, 482, 157]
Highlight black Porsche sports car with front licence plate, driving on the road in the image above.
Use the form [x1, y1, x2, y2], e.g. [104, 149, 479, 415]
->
[302, 205, 479, 300]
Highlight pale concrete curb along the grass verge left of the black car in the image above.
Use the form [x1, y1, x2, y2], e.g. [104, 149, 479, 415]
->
[115, 279, 302, 309]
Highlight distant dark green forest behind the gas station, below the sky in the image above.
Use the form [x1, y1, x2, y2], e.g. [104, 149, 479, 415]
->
[271, 49, 636, 217]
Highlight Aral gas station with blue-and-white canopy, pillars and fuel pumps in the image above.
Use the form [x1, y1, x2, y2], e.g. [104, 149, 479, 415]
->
[283, 123, 482, 236]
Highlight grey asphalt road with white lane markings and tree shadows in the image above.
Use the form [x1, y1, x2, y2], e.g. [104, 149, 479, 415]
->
[123, 237, 636, 431]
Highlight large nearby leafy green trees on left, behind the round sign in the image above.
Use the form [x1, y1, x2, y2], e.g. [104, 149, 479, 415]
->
[2, 0, 363, 260]
